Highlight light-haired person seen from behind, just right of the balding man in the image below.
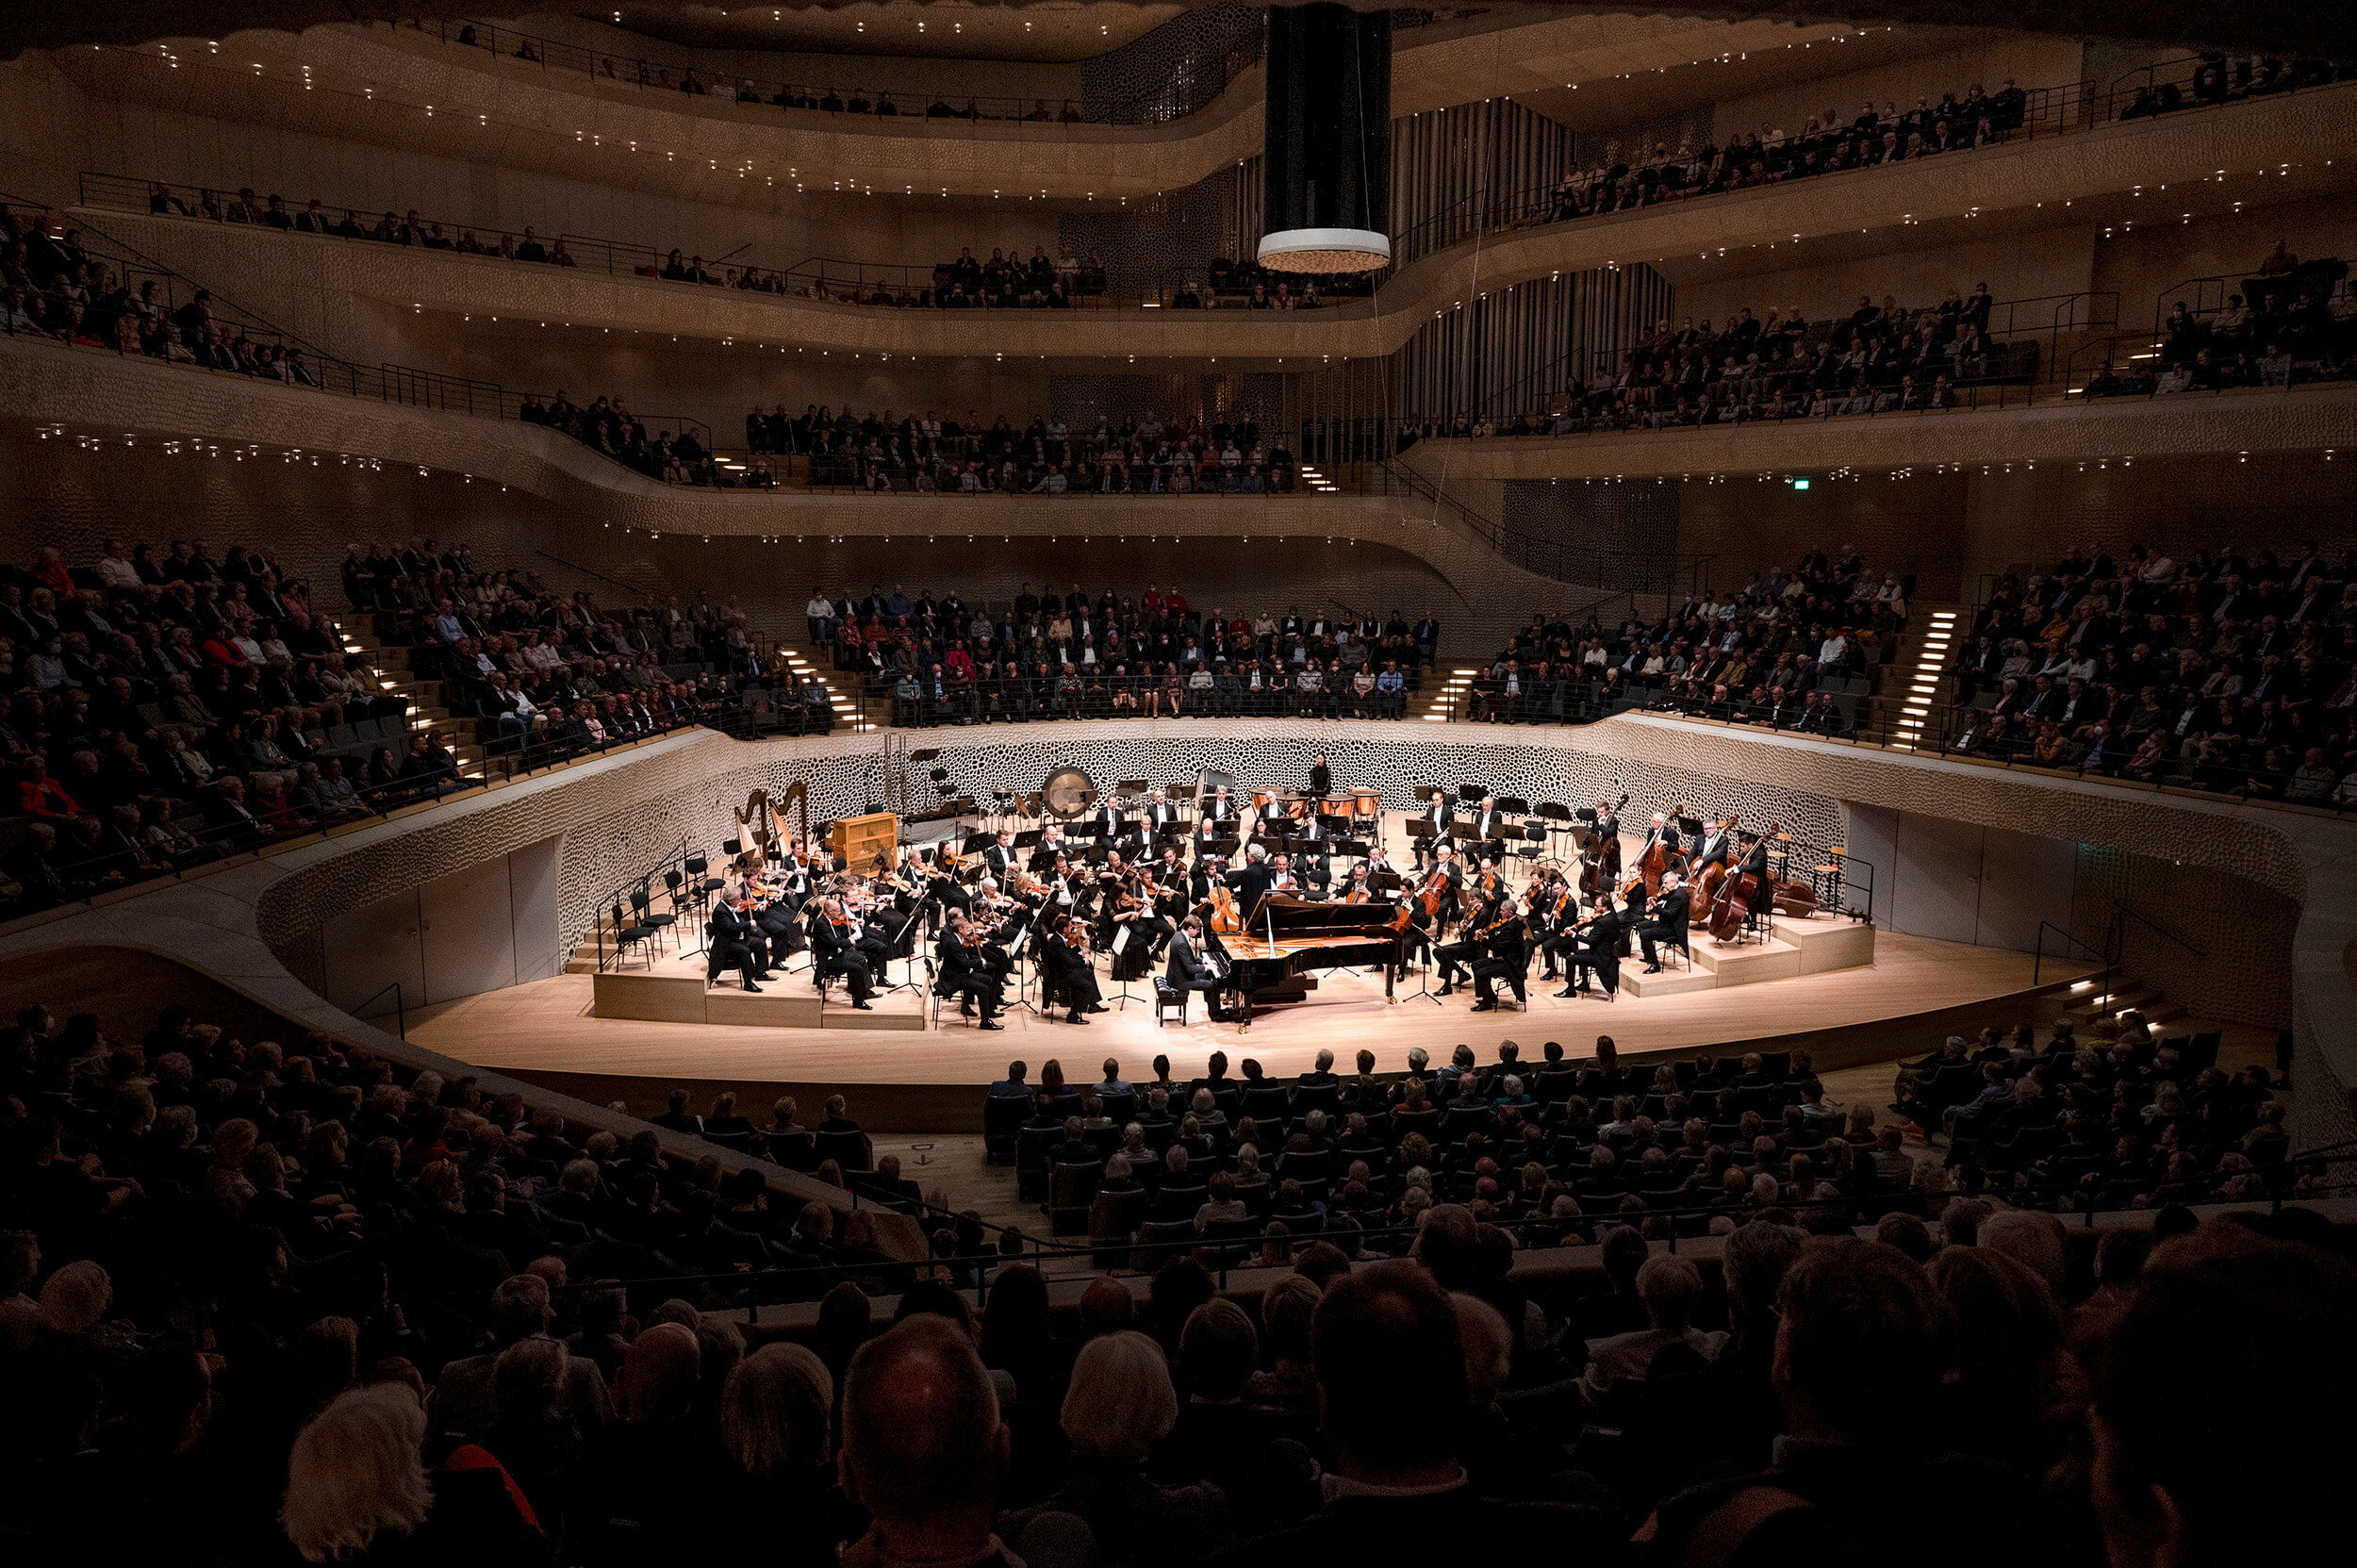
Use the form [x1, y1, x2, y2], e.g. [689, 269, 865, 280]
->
[999, 1329, 1233, 1568]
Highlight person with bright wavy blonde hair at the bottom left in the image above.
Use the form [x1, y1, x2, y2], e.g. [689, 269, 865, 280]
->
[278, 1381, 552, 1568]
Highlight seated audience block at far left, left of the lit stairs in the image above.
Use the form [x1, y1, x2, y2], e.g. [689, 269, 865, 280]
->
[0, 540, 471, 910]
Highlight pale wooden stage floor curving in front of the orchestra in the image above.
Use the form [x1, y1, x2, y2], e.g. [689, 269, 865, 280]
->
[410, 932, 2086, 1127]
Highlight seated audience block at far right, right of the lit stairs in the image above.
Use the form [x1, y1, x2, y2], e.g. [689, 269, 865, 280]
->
[1945, 542, 2357, 806]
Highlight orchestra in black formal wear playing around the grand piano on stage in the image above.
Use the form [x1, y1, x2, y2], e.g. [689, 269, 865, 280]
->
[705, 754, 1813, 1031]
